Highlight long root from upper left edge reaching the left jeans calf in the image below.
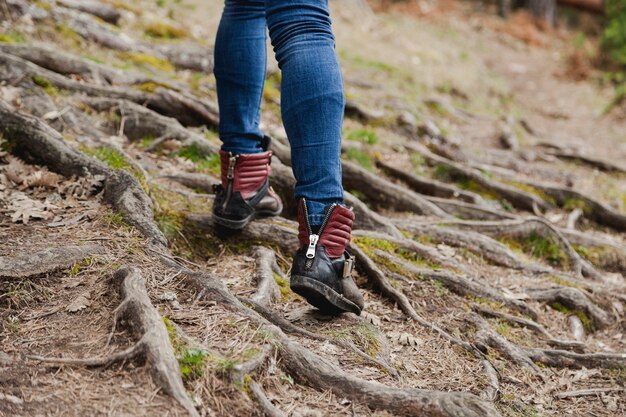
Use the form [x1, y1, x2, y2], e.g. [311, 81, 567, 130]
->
[0, 52, 219, 127]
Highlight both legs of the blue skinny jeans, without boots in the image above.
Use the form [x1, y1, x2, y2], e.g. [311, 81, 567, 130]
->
[214, 0, 345, 225]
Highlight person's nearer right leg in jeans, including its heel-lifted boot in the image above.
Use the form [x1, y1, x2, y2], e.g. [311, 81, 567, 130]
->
[265, 0, 364, 314]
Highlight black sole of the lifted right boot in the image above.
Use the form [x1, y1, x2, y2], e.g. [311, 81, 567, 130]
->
[290, 275, 361, 316]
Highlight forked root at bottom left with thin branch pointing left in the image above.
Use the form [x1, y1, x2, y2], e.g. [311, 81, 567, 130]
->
[26, 267, 199, 416]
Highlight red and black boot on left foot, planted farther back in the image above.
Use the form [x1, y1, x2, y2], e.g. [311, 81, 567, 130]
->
[213, 141, 283, 230]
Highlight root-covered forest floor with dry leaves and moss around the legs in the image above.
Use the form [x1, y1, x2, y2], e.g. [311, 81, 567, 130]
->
[0, 0, 626, 417]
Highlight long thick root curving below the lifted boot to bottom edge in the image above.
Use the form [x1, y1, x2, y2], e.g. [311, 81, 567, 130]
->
[179, 273, 499, 417]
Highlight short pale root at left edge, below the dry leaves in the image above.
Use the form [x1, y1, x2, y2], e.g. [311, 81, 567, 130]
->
[0, 245, 105, 278]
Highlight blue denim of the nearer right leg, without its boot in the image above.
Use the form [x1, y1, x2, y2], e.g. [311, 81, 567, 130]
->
[266, 0, 345, 226]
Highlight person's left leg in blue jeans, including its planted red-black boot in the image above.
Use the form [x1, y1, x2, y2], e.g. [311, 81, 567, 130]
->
[213, 0, 282, 230]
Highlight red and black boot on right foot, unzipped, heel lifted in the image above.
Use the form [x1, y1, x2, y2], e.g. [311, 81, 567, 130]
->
[291, 198, 364, 315]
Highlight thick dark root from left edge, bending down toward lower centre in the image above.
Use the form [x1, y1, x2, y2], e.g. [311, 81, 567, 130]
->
[0, 100, 167, 246]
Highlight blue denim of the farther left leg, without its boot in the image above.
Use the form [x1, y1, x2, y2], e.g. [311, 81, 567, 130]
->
[214, 0, 267, 154]
